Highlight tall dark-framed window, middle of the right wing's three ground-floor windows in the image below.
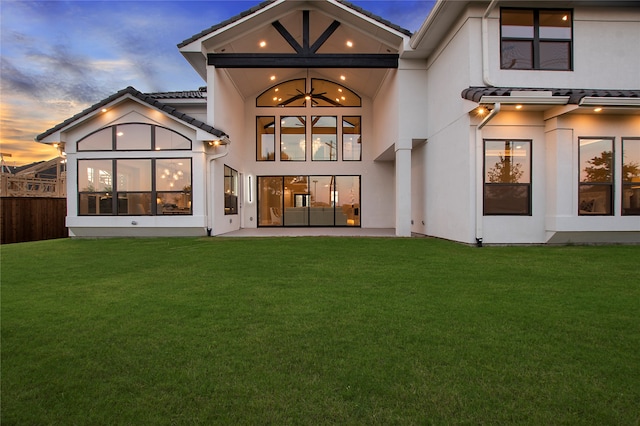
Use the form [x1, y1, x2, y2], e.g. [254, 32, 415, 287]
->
[578, 138, 614, 215]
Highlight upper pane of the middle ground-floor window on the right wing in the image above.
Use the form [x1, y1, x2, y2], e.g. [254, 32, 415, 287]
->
[580, 139, 613, 183]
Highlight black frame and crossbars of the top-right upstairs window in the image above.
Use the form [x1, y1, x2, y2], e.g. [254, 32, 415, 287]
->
[500, 7, 575, 71]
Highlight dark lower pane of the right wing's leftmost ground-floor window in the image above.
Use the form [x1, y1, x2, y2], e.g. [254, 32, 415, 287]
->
[484, 184, 531, 215]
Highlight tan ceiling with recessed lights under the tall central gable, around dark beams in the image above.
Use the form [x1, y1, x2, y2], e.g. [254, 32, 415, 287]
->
[181, 0, 410, 99]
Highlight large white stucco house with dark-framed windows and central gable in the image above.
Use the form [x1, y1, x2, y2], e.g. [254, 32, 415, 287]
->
[36, 0, 640, 244]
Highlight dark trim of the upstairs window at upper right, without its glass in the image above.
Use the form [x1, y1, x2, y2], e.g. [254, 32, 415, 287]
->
[500, 7, 575, 71]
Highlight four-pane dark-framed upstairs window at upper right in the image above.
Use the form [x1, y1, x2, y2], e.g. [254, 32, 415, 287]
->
[500, 9, 573, 71]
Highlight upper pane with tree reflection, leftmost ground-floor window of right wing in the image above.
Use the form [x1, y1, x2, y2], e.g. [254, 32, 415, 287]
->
[485, 141, 531, 183]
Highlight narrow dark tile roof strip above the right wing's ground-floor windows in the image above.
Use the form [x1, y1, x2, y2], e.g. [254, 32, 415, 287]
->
[461, 86, 640, 105]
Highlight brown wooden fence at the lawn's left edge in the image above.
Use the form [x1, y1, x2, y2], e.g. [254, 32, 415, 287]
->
[0, 197, 69, 244]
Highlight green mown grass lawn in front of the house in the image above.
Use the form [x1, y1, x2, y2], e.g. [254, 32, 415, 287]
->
[0, 237, 640, 426]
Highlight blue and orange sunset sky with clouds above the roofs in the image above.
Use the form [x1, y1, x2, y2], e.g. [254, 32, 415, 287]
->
[0, 0, 434, 165]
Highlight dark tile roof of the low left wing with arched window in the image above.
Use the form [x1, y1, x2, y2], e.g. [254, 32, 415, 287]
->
[35, 86, 228, 142]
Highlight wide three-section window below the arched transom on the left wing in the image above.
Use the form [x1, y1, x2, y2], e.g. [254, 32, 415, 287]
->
[78, 158, 192, 216]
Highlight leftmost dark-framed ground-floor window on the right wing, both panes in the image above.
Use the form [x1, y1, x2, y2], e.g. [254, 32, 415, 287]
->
[484, 140, 531, 215]
